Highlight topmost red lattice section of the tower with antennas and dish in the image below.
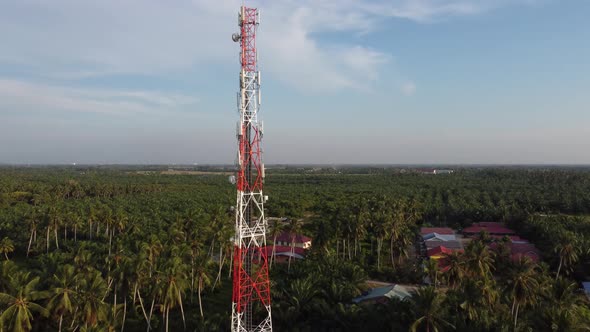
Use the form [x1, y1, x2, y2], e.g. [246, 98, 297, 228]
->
[232, 6, 260, 72]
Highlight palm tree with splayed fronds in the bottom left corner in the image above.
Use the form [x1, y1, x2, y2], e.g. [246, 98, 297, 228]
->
[0, 272, 48, 332]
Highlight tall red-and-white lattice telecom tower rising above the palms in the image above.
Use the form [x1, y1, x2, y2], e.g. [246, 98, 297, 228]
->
[232, 6, 272, 332]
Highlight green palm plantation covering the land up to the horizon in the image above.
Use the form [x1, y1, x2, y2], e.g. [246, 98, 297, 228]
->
[0, 167, 590, 331]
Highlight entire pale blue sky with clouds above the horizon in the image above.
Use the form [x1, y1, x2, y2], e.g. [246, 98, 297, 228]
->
[0, 0, 590, 164]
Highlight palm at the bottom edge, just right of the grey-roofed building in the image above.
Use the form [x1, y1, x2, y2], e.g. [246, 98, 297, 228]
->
[409, 286, 454, 332]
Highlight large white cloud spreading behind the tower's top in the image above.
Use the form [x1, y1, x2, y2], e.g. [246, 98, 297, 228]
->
[0, 0, 531, 91]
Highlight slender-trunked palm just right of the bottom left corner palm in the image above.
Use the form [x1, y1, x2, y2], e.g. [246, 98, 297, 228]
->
[47, 265, 78, 332]
